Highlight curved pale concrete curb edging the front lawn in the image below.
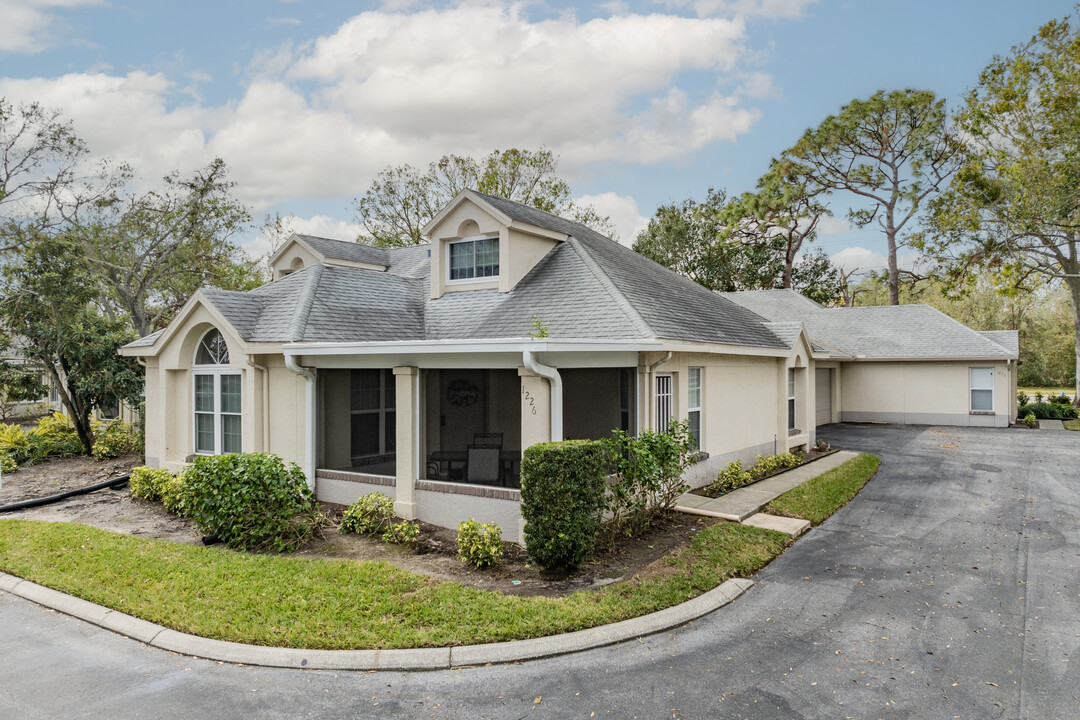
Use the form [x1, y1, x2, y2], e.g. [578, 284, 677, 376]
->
[0, 572, 754, 670]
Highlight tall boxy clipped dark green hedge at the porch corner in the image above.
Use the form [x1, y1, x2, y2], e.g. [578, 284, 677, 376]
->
[522, 440, 607, 568]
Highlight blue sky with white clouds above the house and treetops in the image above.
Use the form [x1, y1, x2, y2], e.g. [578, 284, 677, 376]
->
[0, 0, 1072, 267]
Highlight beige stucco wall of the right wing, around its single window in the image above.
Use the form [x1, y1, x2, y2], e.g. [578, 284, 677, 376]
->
[840, 361, 1016, 427]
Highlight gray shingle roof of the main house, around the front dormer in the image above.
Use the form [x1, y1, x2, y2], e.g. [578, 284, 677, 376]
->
[130, 193, 788, 349]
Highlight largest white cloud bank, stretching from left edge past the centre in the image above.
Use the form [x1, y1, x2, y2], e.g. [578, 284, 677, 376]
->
[0, 0, 771, 209]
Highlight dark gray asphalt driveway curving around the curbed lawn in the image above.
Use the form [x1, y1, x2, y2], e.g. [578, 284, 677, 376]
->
[0, 425, 1080, 719]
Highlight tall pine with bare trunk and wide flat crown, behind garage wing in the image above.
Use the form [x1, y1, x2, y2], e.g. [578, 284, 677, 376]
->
[785, 90, 959, 304]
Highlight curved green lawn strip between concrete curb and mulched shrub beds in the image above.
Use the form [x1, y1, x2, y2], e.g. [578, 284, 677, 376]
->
[0, 519, 789, 650]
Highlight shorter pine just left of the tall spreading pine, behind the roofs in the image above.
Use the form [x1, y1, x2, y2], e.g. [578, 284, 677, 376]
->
[720, 160, 835, 289]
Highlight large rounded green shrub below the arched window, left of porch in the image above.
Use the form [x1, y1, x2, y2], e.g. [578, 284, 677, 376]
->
[180, 452, 320, 553]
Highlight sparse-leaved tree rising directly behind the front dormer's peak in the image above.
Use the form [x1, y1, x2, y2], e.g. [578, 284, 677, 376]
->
[353, 148, 611, 247]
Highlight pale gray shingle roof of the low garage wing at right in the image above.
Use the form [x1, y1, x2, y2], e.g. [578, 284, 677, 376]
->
[724, 290, 1016, 359]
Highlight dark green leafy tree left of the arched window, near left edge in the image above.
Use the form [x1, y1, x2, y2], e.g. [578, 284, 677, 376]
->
[0, 232, 143, 452]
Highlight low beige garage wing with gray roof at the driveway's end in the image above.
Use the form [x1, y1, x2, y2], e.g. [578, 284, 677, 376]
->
[723, 290, 1020, 427]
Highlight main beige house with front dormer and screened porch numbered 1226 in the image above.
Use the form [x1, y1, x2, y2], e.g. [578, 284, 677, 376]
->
[121, 190, 1015, 541]
